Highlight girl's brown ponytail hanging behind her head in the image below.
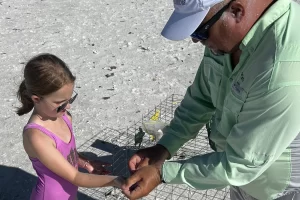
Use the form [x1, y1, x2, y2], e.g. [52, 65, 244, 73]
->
[16, 80, 34, 116]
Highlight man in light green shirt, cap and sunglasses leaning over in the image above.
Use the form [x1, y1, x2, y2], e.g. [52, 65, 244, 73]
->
[123, 0, 300, 200]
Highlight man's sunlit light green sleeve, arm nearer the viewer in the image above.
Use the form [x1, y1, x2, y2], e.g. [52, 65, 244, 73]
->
[162, 86, 300, 189]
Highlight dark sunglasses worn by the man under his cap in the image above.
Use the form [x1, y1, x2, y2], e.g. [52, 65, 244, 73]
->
[191, 0, 235, 41]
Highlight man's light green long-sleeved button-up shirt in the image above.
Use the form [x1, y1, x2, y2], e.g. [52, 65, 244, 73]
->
[158, 0, 300, 200]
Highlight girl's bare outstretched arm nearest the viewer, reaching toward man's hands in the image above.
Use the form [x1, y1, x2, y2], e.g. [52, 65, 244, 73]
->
[23, 129, 122, 187]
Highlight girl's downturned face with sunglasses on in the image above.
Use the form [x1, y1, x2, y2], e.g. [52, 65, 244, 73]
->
[32, 83, 77, 118]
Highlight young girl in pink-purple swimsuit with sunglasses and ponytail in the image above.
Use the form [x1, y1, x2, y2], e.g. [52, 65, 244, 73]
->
[17, 54, 123, 200]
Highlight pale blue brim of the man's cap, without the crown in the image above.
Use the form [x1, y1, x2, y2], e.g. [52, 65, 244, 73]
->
[161, 9, 209, 40]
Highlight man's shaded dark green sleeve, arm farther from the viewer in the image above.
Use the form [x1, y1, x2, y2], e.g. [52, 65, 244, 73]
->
[158, 54, 216, 157]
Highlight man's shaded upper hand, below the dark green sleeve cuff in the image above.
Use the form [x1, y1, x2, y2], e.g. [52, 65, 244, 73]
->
[128, 144, 170, 173]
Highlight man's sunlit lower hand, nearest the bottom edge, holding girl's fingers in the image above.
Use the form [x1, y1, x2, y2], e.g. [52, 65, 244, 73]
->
[122, 165, 161, 200]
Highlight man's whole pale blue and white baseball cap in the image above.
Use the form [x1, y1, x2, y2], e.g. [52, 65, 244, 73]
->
[161, 0, 223, 40]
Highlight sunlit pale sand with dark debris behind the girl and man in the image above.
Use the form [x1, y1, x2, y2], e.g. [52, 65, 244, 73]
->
[0, 0, 298, 199]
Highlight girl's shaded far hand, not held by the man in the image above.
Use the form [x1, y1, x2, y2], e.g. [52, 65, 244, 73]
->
[84, 160, 111, 175]
